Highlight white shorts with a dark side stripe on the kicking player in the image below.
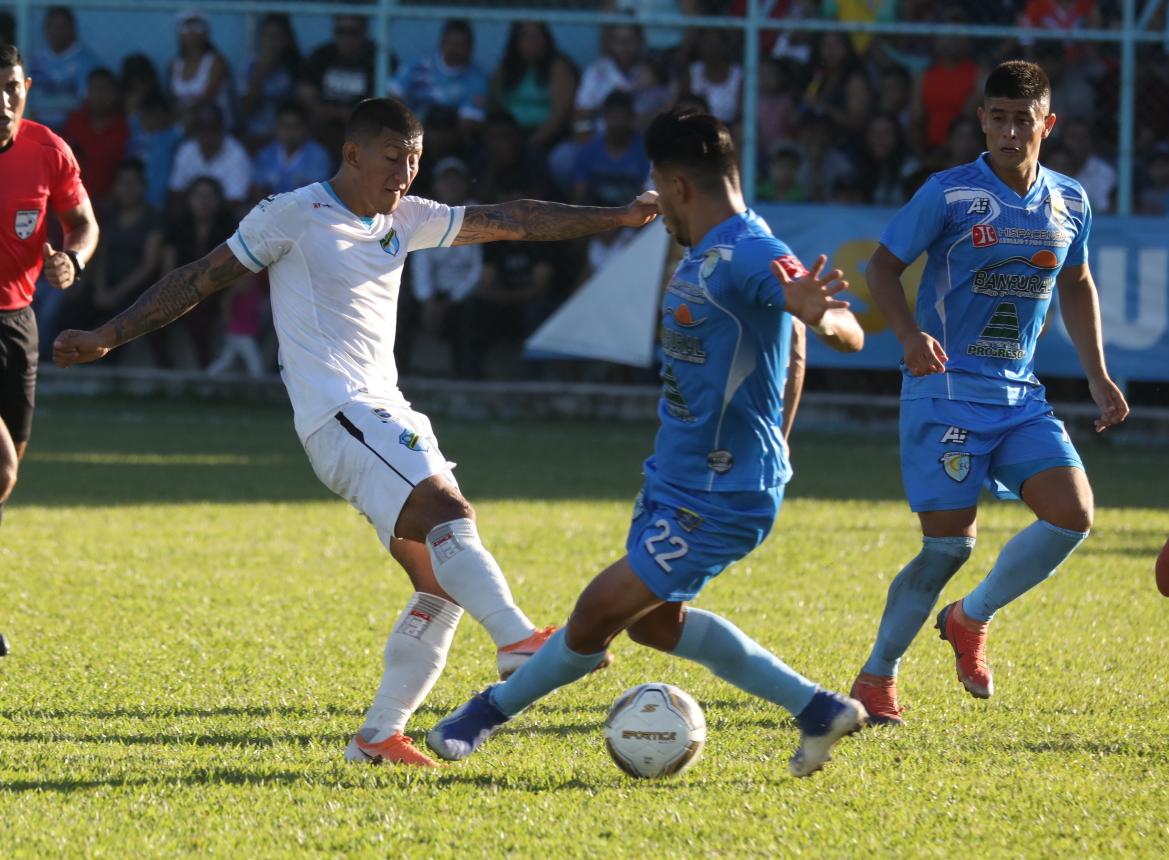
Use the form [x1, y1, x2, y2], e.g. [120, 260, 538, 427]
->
[304, 402, 458, 547]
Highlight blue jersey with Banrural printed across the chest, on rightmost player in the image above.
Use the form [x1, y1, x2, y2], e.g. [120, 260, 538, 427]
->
[880, 154, 1092, 405]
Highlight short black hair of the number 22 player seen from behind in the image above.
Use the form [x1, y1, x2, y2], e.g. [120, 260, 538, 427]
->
[645, 110, 739, 190]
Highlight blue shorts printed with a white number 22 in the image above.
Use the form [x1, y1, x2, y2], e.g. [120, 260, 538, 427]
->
[625, 458, 783, 601]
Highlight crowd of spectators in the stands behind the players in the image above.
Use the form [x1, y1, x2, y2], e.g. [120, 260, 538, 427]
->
[9, 0, 1169, 377]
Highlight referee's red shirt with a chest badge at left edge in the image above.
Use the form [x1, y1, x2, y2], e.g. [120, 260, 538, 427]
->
[0, 119, 87, 311]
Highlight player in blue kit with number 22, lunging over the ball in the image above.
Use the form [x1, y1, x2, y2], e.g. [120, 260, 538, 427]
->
[427, 112, 865, 776]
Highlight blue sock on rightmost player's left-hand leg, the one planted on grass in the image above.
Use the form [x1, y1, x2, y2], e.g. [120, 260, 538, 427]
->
[864, 538, 974, 675]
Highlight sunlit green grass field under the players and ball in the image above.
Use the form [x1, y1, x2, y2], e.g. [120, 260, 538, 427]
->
[0, 400, 1169, 859]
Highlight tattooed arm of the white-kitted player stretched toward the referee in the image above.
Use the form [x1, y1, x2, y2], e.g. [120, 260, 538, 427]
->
[53, 244, 248, 367]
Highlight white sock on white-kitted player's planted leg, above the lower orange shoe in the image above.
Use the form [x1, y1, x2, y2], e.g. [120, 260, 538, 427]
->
[361, 591, 463, 743]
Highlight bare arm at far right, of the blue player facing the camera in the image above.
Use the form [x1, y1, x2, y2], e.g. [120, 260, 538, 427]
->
[1056, 263, 1128, 432]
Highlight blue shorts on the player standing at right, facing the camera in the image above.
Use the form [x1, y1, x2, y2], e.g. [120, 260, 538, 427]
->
[901, 397, 1084, 511]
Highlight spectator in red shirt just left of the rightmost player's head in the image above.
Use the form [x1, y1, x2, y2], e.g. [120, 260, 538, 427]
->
[915, 22, 983, 151]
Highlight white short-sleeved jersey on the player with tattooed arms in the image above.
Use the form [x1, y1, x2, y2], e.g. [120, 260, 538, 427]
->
[227, 182, 464, 442]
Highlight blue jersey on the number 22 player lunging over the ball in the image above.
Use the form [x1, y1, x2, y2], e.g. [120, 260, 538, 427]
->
[653, 210, 803, 492]
